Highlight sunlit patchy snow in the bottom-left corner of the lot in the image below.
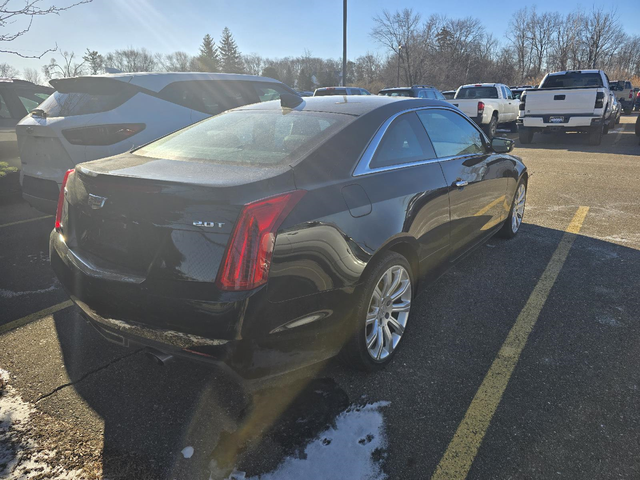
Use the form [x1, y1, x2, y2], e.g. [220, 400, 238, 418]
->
[0, 369, 83, 480]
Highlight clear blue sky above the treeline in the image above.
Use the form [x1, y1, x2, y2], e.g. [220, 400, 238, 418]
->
[0, 0, 640, 74]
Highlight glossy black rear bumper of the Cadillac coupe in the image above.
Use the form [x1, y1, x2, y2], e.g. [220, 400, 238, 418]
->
[49, 230, 355, 379]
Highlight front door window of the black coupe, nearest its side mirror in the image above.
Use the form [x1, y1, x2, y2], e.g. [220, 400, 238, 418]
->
[418, 109, 486, 158]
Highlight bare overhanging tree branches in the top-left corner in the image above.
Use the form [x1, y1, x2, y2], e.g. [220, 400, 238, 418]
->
[0, 0, 93, 58]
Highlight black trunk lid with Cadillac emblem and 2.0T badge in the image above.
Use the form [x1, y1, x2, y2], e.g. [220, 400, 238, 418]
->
[67, 154, 295, 282]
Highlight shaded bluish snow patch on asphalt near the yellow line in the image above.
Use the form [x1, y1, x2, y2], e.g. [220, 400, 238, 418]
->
[219, 402, 389, 480]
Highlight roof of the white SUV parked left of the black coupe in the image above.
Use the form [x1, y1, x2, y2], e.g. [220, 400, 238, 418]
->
[54, 72, 282, 92]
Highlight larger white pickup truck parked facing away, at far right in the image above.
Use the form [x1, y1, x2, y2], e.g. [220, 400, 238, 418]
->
[518, 70, 614, 145]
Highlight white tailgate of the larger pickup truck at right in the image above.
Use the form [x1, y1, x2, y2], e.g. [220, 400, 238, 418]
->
[525, 88, 598, 115]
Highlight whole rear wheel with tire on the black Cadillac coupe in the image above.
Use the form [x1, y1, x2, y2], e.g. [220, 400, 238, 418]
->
[339, 252, 415, 372]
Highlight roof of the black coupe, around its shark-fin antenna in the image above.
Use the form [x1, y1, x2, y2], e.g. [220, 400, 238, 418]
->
[235, 95, 452, 116]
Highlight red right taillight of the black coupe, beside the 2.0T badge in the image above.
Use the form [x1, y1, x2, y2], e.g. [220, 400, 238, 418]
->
[216, 190, 306, 291]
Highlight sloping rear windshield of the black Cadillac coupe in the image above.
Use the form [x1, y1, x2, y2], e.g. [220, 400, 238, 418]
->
[135, 110, 356, 166]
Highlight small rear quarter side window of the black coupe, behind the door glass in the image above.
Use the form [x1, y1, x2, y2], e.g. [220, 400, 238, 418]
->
[370, 112, 435, 168]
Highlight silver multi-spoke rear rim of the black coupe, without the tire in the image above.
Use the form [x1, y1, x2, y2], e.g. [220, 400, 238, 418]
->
[364, 265, 411, 362]
